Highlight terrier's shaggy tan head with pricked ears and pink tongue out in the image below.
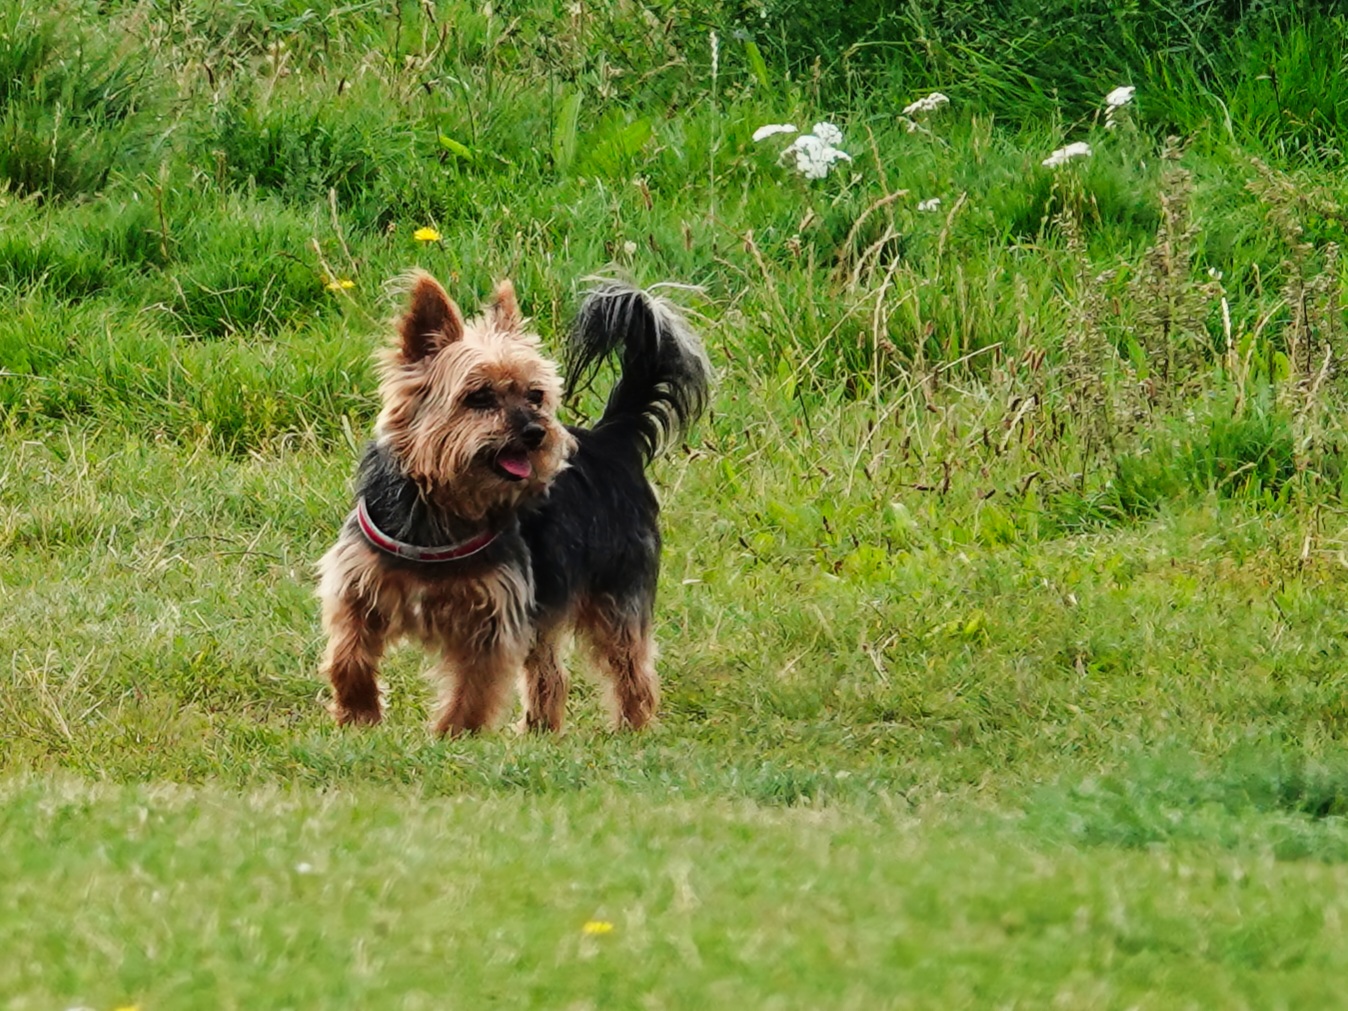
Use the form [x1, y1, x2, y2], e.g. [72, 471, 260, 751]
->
[376, 272, 576, 519]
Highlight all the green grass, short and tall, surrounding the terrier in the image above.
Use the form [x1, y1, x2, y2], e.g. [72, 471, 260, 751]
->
[0, 0, 1348, 1011]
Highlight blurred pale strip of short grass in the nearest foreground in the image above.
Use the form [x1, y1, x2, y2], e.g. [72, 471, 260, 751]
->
[13, 782, 1344, 1008]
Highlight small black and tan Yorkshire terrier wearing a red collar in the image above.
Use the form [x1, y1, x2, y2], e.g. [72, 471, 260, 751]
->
[318, 272, 710, 735]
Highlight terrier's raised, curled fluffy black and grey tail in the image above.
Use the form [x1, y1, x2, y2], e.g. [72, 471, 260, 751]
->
[566, 279, 712, 460]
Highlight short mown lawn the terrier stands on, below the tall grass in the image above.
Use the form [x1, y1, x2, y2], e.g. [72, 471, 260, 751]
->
[0, 420, 1348, 1008]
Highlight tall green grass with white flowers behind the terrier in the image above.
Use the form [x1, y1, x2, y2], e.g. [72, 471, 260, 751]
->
[0, 3, 1344, 515]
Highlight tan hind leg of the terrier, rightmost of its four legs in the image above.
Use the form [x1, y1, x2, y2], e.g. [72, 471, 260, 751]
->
[577, 601, 661, 731]
